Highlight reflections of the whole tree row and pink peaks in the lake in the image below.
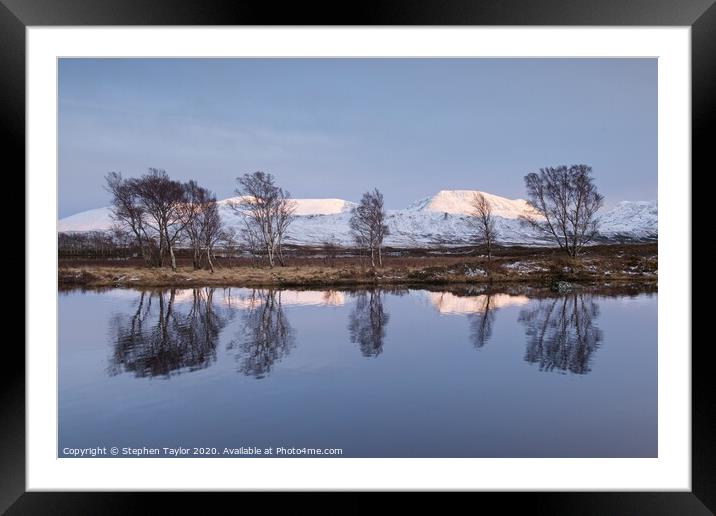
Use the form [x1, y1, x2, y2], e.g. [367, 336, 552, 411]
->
[108, 288, 602, 378]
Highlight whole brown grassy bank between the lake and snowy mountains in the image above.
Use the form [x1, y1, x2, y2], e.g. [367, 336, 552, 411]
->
[58, 245, 658, 288]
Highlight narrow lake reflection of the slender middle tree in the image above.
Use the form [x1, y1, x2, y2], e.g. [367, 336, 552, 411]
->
[348, 290, 390, 357]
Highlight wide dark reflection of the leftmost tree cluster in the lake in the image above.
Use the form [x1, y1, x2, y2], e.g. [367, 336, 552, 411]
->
[108, 288, 228, 377]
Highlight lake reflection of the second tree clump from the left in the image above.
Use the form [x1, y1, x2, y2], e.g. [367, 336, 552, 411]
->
[229, 290, 294, 378]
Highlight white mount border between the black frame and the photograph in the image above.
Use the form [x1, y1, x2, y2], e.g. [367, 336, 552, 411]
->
[27, 27, 691, 491]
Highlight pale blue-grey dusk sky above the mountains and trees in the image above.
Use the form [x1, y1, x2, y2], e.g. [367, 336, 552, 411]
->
[58, 58, 657, 217]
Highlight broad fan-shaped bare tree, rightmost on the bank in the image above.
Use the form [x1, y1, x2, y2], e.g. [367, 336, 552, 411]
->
[522, 165, 604, 257]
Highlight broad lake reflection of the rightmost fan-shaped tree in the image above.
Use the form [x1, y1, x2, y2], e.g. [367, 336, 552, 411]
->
[519, 293, 603, 374]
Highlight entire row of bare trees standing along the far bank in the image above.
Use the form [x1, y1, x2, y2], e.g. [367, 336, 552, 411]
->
[106, 165, 603, 272]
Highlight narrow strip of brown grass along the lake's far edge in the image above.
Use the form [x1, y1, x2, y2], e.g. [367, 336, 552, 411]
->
[58, 257, 658, 289]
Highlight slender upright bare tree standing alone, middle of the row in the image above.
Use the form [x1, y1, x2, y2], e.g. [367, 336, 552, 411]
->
[349, 188, 390, 268]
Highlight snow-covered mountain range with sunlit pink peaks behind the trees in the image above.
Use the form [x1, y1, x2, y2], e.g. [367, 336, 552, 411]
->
[58, 190, 658, 247]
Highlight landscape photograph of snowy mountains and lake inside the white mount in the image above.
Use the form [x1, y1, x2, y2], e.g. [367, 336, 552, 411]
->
[57, 57, 668, 460]
